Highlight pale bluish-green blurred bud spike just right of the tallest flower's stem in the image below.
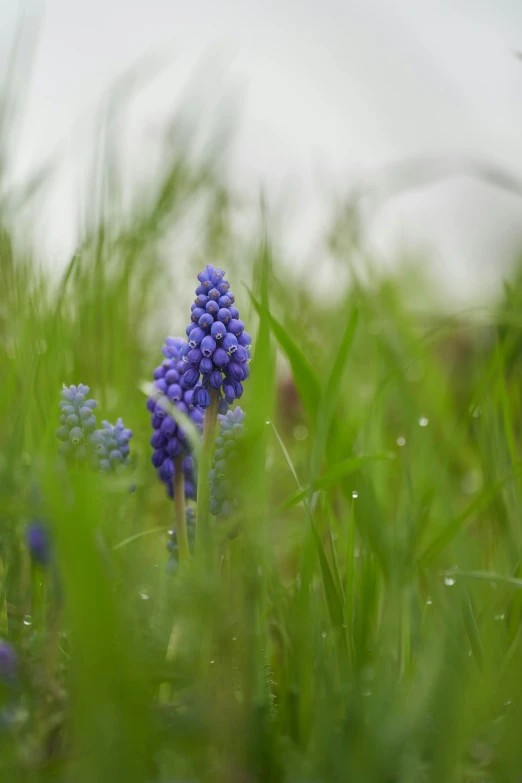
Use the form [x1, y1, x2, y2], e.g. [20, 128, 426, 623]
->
[209, 406, 246, 517]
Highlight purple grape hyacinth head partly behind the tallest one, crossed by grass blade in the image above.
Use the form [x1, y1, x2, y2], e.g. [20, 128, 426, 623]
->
[147, 337, 204, 498]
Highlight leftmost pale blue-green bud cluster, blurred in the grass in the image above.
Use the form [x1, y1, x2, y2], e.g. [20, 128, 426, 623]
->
[56, 383, 97, 462]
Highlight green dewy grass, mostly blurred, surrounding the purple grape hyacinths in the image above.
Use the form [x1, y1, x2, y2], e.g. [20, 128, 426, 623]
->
[0, 32, 522, 783]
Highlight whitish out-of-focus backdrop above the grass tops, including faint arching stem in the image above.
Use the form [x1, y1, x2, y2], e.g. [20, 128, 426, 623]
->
[0, 0, 522, 303]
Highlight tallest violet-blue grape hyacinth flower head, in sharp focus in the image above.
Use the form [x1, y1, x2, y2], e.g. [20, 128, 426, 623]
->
[182, 264, 252, 413]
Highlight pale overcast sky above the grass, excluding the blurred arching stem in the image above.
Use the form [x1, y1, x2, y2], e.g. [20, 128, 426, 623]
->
[0, 0, 522, 300]
